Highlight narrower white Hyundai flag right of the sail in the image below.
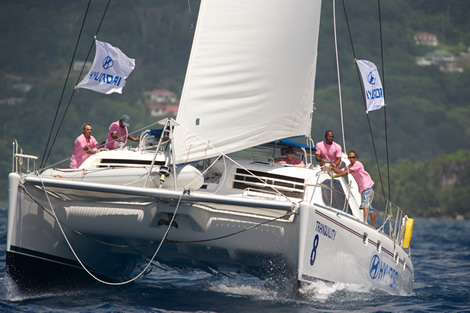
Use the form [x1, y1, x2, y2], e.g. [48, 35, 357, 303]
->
[356, 60, 385, 112]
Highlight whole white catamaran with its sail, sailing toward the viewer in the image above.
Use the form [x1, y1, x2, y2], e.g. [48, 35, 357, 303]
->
[6, 0, 414, 294]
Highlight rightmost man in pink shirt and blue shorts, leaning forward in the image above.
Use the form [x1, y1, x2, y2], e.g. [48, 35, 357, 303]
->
[328, 150, 375, 227]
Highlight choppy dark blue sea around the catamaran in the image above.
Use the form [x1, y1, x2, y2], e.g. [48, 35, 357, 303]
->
[0, 208, 470, 313]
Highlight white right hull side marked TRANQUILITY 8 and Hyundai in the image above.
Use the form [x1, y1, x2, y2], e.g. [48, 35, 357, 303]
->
[299, 202, 414, 294]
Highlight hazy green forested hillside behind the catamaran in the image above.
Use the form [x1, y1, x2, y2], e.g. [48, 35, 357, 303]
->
[0, 0, 470, 217]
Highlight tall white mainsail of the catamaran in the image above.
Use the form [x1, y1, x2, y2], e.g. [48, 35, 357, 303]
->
[173, 0, 321, 163]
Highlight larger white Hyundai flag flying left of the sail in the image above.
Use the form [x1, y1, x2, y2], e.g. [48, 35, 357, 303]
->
[75, 40, 135, 94]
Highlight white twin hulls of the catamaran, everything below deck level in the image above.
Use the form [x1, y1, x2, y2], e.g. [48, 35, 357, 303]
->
[7, 168, 413, 293]
